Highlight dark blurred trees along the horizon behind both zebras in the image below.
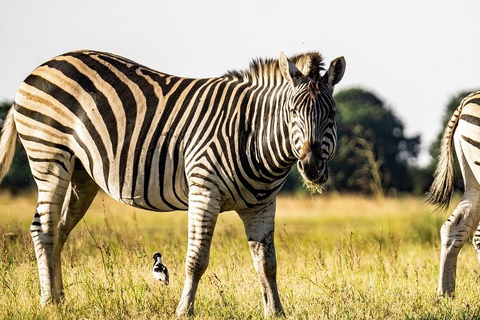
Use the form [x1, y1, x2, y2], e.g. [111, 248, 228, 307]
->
[0, 88, 473, 197]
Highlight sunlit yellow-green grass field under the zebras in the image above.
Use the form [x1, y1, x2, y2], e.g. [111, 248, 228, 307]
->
[0, 194, 480, 319]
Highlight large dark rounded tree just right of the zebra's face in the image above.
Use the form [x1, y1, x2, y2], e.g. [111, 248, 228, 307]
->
[330, 88, 420, 197]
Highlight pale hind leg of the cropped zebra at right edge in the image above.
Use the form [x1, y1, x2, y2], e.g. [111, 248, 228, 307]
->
[438, 190, 480, 296]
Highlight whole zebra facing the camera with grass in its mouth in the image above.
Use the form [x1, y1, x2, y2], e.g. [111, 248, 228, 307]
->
[0, 51, 345, 315]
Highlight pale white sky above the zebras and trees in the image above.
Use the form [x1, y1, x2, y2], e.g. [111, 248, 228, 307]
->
[0, 0, 480, 165]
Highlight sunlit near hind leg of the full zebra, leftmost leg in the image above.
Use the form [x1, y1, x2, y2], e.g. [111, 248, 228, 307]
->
[30, 158, 73, 305]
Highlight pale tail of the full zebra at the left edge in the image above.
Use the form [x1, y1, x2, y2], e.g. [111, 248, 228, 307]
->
[0, 107, 17, 182]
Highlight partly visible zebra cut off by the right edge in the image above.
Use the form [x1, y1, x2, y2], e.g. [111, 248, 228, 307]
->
[428, 91, 480, 295]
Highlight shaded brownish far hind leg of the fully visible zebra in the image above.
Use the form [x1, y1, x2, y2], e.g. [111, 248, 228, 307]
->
[54, 160, 99, 299]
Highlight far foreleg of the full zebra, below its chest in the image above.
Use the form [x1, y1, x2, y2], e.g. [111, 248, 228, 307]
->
[240, 201, 284, 317]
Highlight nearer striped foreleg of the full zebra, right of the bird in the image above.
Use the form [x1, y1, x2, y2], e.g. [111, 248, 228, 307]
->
[176, 188, 220, 317]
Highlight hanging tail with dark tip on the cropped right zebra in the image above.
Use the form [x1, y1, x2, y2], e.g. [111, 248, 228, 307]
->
[426, 103, 464, 210]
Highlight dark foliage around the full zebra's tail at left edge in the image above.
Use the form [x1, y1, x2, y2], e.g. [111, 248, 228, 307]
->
[0, 101, 35, 194]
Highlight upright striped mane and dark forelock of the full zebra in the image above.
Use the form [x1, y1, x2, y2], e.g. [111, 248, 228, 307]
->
[225, 51, 325, 89]
